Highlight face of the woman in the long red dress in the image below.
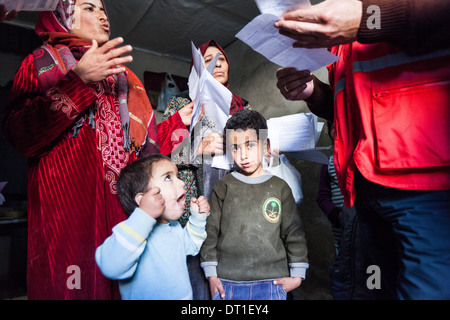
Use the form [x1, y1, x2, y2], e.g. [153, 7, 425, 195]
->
[72, 0, 110, 45]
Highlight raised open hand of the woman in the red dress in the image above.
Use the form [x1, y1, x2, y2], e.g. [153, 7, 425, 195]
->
[73, 37, 133, 83]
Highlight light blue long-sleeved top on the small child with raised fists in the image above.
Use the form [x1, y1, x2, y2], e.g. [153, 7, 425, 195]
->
[95, 208, 207, 300]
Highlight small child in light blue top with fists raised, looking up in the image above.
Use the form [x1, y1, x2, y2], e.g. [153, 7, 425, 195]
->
[95, 154, 209, 300]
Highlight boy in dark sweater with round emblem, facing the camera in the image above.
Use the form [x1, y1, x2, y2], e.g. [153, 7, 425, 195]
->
[200, 110, 309, 300]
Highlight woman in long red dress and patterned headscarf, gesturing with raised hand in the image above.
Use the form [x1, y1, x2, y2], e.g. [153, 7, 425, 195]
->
[3, 0, 159, 299]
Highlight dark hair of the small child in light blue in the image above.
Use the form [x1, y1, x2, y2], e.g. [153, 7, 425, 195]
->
[116, 154, 172, 216]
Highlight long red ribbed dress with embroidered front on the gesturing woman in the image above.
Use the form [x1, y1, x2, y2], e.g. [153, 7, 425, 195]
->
[4, 55, 136, 299]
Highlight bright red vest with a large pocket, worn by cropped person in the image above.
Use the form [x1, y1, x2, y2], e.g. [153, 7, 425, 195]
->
[328, 42, 450, 207]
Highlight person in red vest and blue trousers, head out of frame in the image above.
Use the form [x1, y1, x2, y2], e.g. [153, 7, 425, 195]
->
[275, 0, 450, 299]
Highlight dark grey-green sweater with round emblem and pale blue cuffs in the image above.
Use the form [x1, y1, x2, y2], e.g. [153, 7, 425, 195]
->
[200, 172, 309, 281]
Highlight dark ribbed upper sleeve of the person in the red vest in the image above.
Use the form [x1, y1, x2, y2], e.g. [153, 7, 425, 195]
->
[357, 0, 450, 54]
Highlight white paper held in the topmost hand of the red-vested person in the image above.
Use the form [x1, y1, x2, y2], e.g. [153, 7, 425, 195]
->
[236, 0, 339, 71]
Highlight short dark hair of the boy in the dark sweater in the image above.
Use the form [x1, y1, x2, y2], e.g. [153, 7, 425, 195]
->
[224, 110, 267, 141]
